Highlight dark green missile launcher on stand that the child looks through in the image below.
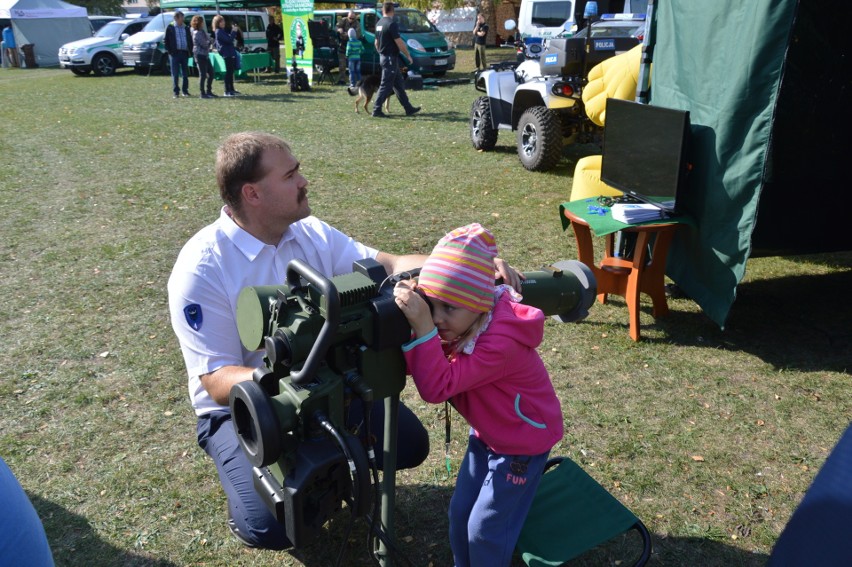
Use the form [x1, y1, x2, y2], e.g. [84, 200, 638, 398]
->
[230, 259, 596, 565]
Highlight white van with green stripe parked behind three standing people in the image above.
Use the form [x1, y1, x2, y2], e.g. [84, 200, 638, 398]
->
[122, 10, 269, 72]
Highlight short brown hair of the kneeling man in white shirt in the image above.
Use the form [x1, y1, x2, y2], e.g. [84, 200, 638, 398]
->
[216, 132, 292, 217]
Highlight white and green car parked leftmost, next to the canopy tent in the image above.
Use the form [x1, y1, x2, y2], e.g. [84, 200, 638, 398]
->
[59, 18, 151, 77]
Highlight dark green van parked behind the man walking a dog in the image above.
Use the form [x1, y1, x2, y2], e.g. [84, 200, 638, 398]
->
[312, 8, 456, 77]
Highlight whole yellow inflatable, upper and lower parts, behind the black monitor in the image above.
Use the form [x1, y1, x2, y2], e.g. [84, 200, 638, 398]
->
[569, 44, 642, 201]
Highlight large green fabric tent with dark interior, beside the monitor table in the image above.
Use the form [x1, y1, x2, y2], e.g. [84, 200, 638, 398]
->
[649, 0, 852, 326]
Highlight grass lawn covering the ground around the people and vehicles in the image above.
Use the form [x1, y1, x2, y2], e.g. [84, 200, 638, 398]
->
[0, 49, 852, 567]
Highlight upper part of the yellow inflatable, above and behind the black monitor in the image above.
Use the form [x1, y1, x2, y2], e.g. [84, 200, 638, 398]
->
[583, 44, 642, 126]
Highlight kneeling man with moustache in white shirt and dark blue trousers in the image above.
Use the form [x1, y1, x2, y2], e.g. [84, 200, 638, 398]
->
[168, 132, 520, 549]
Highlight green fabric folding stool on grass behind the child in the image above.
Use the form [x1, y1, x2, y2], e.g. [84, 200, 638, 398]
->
[516, 457, 651, 567]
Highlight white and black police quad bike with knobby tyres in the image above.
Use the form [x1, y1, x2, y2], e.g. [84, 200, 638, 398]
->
[470, 37, 638, 171]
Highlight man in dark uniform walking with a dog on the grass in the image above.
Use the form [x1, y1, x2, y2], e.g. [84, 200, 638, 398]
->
[373, 2, 420, 118]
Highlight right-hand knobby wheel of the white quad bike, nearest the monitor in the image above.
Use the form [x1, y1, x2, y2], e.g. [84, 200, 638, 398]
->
[518, 106, 562, 171]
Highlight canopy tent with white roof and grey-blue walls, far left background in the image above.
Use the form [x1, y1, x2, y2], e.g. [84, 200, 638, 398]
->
[0, 0, 92, 67]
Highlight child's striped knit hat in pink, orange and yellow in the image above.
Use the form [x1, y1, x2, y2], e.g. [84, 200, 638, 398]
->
[417, 223, 497, 313]
